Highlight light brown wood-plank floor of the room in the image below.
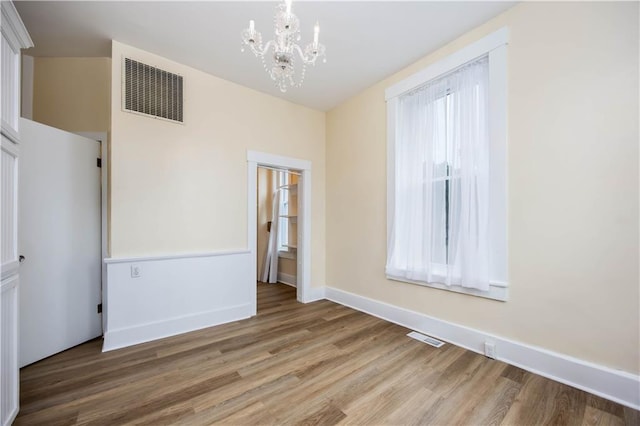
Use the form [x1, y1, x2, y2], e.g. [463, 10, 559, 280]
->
[15, 284, 640, 425]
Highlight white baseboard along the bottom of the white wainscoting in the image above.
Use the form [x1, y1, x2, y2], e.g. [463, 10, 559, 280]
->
[102, 304, 252, 352]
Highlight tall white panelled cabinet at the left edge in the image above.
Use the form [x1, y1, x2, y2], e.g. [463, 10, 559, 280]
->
[0, 1, 33, 426]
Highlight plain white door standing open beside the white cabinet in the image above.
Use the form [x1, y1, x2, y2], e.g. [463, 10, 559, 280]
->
[18, 119, 102, 366]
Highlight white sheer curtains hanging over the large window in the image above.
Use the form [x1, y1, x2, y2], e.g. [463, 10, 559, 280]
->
[386, 57, 490, 291]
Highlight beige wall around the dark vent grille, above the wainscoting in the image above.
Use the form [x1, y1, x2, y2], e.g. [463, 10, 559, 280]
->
[111, 42, 325, 286]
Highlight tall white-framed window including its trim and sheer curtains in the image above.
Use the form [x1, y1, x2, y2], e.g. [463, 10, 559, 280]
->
[386, 29, 507, 300]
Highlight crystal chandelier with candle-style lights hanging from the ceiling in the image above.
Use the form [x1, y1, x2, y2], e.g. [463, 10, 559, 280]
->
[240, 0, 327, 92]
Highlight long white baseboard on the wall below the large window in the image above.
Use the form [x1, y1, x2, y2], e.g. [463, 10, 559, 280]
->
[325, 287, 640, 410]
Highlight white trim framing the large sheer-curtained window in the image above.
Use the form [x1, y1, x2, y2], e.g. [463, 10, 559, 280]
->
[385, 27, 509, 301]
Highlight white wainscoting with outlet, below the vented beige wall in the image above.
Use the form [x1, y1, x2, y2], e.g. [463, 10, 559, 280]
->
[103, 250, 255, 351]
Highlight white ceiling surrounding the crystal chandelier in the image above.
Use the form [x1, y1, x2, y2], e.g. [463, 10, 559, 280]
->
[14, 0, 515, 111]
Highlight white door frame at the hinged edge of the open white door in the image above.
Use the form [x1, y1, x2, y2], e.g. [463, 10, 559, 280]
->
[74, 132, 109, 335]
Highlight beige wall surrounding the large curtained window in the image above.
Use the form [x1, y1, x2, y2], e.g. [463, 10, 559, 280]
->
[327, 2, 640, 374]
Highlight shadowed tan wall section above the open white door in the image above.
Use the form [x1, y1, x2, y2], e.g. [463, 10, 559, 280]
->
[33, 58, 111, 132]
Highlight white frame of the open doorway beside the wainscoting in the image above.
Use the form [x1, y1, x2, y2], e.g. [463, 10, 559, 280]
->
[247, 151, 315, 315]
